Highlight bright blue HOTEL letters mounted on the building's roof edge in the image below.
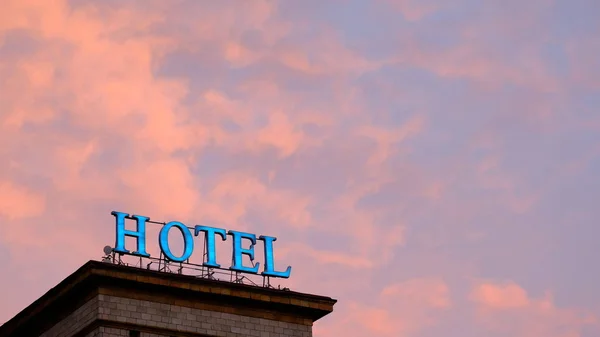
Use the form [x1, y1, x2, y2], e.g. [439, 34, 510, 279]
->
[111, 211, 292, 278]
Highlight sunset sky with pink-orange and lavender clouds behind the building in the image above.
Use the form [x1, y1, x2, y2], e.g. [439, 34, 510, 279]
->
[0, 0, 600, 337]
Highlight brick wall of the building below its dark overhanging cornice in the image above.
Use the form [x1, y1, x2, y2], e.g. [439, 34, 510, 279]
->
[41, 294, 312, 337]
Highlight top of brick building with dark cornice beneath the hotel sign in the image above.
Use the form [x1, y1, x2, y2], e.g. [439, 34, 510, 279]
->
[0, 261, 336, 337]
